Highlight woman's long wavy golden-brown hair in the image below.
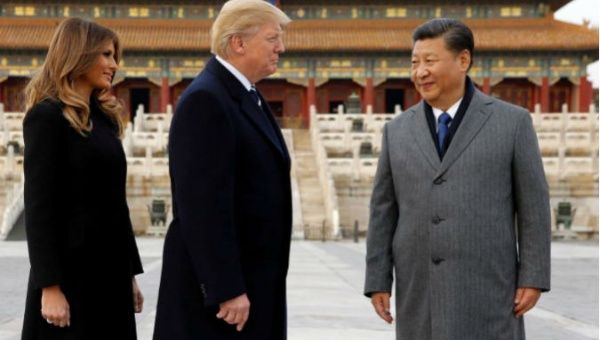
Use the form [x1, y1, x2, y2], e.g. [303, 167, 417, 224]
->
[25, 18, 123, 135]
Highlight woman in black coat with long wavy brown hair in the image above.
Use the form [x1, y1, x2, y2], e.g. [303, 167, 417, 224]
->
[22, 18, 143, 340]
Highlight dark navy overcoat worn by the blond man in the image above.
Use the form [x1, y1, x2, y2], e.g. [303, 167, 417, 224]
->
[154, 58, 292, 340]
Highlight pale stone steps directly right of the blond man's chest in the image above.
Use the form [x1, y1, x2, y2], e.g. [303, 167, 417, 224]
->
[293, 129, 327, 240]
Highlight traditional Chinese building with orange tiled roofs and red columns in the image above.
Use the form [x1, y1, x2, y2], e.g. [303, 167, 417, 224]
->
[0, 0, 598, 127]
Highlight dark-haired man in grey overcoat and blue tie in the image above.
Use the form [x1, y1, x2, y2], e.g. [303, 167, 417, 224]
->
[365, 19, 550, 340]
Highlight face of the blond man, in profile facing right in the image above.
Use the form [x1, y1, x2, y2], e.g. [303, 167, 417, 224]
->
[238, 22, 285, 83]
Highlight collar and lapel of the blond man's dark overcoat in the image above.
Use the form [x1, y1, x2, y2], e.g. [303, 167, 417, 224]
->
[206, 57, 289, 163]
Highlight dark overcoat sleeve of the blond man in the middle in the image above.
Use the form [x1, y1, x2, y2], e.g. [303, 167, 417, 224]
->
[169, 91, 246, 306]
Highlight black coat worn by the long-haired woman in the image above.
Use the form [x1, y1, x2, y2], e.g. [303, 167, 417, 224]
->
[22, 99, 142, 340]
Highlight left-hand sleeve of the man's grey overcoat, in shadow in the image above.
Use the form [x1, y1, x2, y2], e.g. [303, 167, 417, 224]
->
[364, 124, 399, 297]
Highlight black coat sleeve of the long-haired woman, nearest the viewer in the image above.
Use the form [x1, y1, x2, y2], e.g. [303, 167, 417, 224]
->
[23, 103, 66, 288]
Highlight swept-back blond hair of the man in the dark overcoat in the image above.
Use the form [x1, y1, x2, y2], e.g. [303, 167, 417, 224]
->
[210, 0, 291, 59]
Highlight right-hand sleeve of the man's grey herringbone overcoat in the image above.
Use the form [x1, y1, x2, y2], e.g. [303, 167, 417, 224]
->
[512, 113, 551, 291]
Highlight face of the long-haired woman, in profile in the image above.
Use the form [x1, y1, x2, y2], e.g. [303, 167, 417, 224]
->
[78, 41, 118, 90]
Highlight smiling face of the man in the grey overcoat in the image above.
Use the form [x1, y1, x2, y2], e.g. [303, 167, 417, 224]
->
[411, 37, 471, 110]
